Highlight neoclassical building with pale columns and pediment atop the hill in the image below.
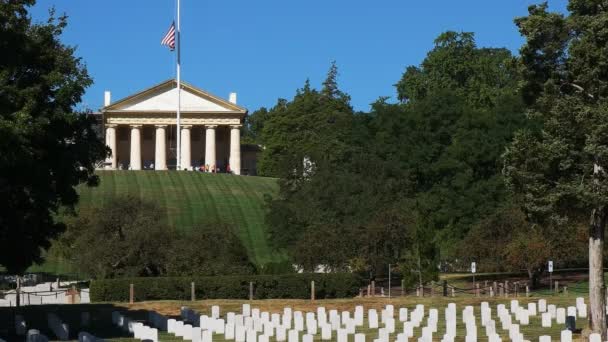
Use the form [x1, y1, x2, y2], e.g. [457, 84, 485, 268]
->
[102, 80, 255, 174]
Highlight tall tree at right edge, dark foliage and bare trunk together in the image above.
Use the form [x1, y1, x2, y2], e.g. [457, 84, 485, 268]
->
[504, 0, 608, 339]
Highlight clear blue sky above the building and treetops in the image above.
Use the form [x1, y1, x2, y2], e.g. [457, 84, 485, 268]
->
[32, 0, 567, 112]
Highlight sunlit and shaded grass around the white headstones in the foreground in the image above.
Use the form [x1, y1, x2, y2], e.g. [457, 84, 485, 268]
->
[0, 294, 587, 341]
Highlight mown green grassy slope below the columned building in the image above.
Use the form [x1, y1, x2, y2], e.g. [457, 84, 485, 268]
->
[31, 171, 285, 272]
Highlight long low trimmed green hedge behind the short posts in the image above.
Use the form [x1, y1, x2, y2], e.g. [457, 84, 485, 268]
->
[90, 273, 363, 302]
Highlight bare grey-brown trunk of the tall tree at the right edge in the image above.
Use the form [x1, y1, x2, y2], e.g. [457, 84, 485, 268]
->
[589, 207, 607, 341]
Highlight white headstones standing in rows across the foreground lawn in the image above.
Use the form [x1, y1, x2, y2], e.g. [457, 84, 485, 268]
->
[117, 298, 586, 342]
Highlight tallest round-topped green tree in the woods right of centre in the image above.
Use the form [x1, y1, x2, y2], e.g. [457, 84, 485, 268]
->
[392, 31, 526, 259]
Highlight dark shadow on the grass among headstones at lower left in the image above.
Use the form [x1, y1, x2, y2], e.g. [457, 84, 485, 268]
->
[0, 304, 163, 341]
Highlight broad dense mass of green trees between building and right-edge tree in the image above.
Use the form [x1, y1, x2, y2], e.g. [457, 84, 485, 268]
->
[261, 32, 526, 282]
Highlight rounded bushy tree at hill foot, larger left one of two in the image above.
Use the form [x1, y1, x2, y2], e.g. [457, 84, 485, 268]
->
[61, 196, 171, 279]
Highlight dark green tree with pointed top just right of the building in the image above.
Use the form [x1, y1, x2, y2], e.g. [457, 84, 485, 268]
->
[258, 63, 353, 178]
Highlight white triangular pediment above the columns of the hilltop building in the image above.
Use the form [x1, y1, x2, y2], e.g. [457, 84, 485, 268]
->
[103, 80, 247, 115]
